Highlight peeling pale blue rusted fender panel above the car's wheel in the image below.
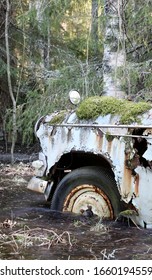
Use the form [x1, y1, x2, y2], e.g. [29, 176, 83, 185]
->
[28, 110, 152, 228]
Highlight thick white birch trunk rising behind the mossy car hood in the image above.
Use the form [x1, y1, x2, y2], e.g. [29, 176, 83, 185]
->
[103, 0, 126, 98]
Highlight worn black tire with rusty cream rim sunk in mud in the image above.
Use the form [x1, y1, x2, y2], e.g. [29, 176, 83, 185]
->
[51, 166, 121, 219]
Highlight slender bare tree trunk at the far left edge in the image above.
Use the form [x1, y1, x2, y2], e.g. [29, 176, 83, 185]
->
[5, 0, 17, 163]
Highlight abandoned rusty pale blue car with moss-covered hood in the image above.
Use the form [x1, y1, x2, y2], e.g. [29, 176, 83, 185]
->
[28, 96, 152, 228]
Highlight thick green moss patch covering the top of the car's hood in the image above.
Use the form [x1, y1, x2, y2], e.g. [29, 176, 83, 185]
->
[76, 96, 152, 124]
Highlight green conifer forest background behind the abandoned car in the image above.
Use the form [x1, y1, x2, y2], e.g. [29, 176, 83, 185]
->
[0, 0, 152, 153]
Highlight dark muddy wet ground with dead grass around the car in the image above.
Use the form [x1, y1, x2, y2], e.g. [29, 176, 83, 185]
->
[0, 163, 152, 260]
